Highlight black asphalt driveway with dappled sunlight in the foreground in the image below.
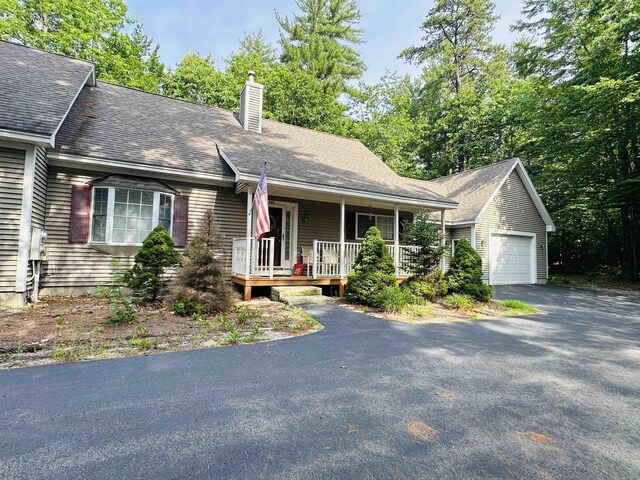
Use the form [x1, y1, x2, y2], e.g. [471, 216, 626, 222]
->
[0, 286, 640, 479]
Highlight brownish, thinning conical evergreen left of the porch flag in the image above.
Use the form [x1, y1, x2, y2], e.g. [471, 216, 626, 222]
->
[171, 210, 237, 315]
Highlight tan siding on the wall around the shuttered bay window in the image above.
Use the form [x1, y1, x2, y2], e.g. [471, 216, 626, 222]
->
[43, 168, 246, 288]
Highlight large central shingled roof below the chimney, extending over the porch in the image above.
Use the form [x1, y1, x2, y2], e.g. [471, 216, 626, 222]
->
[56, 82, 451, 203]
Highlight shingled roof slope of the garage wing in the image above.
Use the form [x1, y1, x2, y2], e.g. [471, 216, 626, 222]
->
[426, 158, 518, 222]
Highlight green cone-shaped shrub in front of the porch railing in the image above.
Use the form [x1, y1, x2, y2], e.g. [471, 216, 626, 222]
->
[345, 227, 396, 306]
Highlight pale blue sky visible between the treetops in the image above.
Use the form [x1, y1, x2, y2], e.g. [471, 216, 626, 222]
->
[127, 0, 523, 82]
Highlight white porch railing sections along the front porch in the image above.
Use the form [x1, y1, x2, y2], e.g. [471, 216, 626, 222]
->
[232, 238, 418, 278]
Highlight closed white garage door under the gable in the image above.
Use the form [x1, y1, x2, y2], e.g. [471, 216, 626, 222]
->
[489, 233, 535, 285]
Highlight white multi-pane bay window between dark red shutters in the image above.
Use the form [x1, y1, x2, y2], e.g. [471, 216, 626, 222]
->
[91, 187, 173, 245]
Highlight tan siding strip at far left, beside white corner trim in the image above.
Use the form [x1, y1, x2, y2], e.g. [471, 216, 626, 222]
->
[0, 148, 25, 293]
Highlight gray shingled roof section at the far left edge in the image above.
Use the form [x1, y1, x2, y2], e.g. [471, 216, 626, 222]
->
[0, 41, 93, 136]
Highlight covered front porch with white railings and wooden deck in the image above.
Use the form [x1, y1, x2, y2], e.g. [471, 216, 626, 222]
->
[231, 185, 445, 300]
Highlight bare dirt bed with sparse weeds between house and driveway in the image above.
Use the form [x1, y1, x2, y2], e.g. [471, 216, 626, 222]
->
[0, 296, 322, 369]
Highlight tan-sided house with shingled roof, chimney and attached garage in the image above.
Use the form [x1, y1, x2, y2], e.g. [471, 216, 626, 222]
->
[0, 42, 553, 305]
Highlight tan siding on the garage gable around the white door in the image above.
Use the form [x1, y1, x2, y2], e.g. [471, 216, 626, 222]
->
[476, 170, 547, 282]
